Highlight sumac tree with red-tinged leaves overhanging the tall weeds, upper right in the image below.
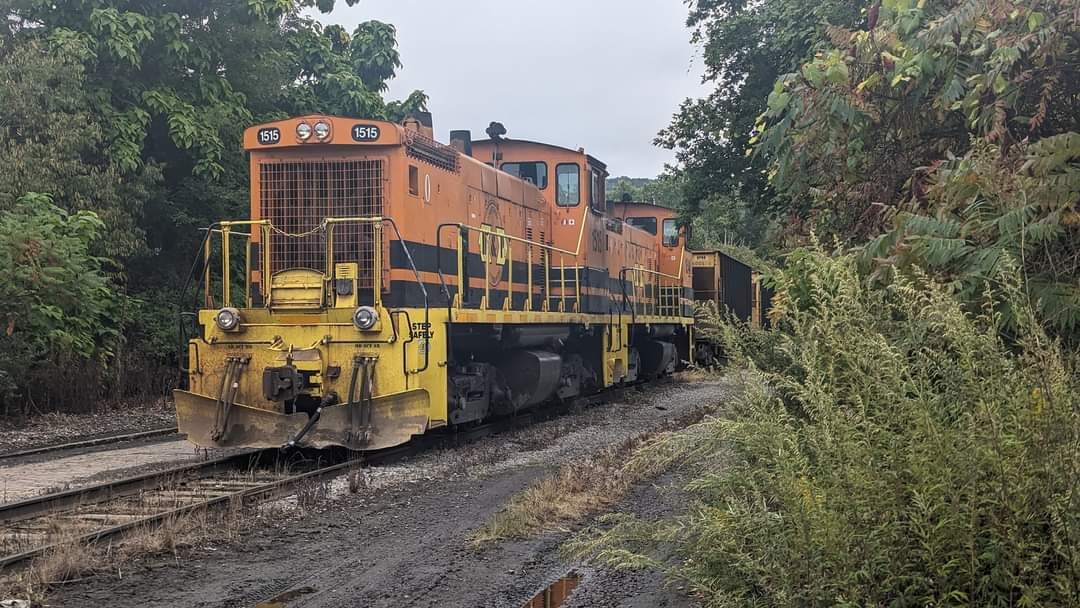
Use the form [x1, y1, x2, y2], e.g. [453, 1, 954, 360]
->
[760, 0, 1080, 332]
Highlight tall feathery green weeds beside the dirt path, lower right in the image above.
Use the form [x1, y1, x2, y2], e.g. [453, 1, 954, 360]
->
[570, 248, 1080, 607]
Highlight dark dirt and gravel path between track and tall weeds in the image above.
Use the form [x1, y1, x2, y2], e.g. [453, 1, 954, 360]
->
[42, 380, 734, 608]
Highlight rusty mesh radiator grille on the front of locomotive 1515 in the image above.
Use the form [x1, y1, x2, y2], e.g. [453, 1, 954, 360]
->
[259, 160, 383, 288]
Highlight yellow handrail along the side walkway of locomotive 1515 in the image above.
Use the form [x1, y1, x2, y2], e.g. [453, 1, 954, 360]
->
[436, 224, 582, 312]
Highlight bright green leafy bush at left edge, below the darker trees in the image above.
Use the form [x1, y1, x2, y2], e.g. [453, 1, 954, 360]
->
[0, 193, 124, 411]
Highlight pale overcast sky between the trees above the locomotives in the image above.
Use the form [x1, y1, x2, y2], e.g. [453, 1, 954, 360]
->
[319, 0, 702, 177]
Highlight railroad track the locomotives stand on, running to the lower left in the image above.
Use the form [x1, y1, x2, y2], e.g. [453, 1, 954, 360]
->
[0, 389, 624, 570]
